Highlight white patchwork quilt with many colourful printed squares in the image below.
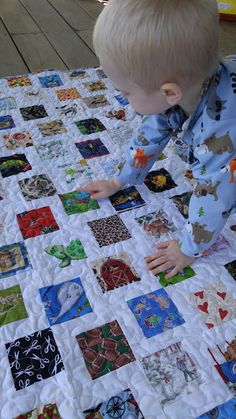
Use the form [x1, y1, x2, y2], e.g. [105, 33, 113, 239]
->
[0, 68, 236, 419]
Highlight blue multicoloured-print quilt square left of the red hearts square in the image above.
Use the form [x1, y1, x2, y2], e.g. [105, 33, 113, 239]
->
[127, 289, 185, 338]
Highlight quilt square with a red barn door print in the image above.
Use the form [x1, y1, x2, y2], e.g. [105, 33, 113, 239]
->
[92, 252, 140, 292]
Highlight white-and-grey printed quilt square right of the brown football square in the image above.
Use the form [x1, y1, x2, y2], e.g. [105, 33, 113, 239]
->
[141, 342, 202, 407]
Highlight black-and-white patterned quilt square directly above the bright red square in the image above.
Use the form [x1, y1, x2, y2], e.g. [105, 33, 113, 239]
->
[18, 175, 57, 201]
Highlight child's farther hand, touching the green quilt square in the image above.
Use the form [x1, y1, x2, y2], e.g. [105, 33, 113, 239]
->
[79, 179, 123, 199]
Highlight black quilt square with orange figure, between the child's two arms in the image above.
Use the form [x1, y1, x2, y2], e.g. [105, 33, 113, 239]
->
[144, 169, 177, 193]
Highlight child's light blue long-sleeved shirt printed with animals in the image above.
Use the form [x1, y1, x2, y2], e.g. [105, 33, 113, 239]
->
[117, 57, 236, 257]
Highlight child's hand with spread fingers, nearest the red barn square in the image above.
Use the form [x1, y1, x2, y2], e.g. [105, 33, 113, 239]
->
[145, 240, 195, 279]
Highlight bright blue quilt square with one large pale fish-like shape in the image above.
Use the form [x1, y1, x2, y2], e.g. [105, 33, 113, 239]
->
[39, 278, 92, 326]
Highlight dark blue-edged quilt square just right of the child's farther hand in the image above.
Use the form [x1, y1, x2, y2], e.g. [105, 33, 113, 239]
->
[109, 186, 146, 212]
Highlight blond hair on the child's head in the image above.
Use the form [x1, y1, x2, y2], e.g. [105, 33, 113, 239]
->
[93, 0, 219, 90]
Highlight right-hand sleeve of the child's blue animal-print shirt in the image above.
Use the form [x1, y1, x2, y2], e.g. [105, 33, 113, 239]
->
[181, 119, 236, 256]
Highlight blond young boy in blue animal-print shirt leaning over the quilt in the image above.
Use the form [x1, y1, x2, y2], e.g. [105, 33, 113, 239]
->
[83, 0, 236, 278]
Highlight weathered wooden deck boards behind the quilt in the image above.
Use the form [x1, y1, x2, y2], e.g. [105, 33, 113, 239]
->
[0, 0, 236, 76]
